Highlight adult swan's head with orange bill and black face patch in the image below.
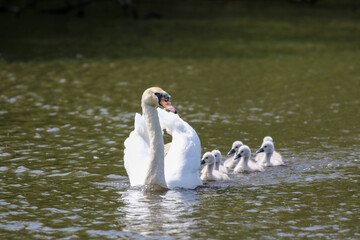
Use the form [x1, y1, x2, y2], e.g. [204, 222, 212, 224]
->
[141, 87, 177, 113]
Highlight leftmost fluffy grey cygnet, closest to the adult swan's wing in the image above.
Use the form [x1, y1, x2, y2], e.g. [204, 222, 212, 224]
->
[200, 152, 230, 181]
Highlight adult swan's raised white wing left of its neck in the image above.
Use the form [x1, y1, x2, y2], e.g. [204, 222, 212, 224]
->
[124, 113, 150, 186]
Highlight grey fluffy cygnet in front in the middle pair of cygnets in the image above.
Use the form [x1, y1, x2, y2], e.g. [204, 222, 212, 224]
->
[234, 145, 264, 173]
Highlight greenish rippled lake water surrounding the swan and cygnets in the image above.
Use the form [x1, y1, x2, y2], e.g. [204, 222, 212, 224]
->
[0, 0, 360, 239]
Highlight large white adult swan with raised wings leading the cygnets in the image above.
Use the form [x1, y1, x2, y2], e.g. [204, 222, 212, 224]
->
[124, 87, 202, 189]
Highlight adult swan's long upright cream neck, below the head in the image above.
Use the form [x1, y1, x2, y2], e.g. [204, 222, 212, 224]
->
[140, 105, 167, 188]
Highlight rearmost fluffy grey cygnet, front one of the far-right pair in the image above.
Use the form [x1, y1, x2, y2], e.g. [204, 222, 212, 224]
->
[256, 141, 284, 167]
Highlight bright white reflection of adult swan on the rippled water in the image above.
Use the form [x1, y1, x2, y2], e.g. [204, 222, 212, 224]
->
[118, 189, 199, 239]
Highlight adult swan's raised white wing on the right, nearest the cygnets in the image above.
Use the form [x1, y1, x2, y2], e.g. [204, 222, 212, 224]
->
[158, 109, 202, 189]
